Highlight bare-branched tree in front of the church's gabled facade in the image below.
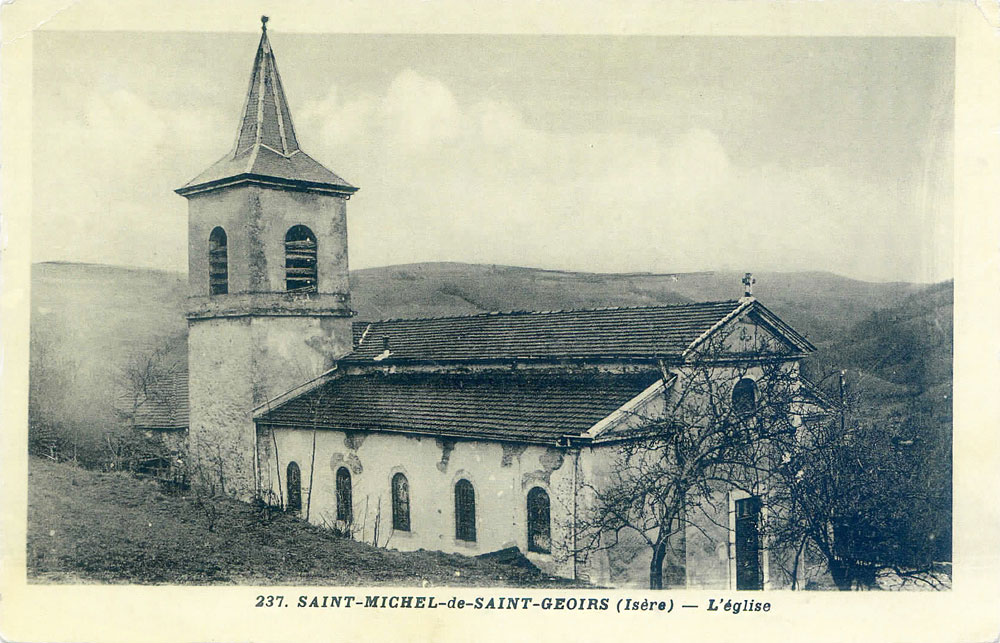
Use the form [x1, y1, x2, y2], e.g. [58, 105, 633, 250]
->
[574, 327, 800, 589]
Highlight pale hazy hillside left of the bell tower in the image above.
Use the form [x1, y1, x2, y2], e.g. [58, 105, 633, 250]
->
[28, 263, 187, 458]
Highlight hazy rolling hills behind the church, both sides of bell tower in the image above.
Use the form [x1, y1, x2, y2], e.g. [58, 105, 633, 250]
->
[31, 263, 951, 458]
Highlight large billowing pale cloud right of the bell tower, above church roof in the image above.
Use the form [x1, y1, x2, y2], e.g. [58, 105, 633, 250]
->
[294, 70, 936, 276]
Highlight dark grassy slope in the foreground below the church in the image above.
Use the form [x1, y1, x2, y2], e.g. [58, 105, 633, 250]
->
[28, 458, 571, 587]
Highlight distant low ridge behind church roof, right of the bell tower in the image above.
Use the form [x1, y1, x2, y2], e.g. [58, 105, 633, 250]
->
[351, 263, 927, 345]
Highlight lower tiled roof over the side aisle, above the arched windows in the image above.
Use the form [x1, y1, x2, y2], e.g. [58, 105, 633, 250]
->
[257, 372, 659, 444]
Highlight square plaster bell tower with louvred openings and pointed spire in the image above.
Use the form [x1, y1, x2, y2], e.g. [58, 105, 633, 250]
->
[176, 16, 357, 498]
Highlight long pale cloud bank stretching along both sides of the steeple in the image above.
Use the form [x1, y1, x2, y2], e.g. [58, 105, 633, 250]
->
[33, 69, 951, 280]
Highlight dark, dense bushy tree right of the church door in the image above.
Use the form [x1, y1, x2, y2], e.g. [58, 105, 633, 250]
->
[769, 374, 950, 590]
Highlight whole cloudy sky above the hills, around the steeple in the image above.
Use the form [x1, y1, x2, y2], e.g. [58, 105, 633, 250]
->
[32, 30, 954, 282]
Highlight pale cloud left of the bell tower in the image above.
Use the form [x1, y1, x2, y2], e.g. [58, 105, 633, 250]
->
[32, 89, 232, 268]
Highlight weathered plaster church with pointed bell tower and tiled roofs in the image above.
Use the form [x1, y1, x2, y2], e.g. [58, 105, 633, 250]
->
[136, 19, 828, 589]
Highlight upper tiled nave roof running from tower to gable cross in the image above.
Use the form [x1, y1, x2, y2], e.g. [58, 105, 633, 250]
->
[345, 301, 741, 362]
